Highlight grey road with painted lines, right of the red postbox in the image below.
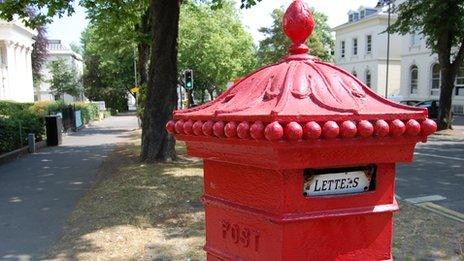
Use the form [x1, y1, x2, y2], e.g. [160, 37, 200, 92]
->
[396, 117, 464, 217]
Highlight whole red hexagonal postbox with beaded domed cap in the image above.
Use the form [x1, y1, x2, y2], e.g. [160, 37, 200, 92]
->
[167, 0, 436, 260]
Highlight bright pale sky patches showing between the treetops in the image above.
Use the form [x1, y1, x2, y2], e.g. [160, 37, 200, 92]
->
[48, 0, 378, 44]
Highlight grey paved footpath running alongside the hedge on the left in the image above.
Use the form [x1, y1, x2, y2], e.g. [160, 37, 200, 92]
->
[0, 116, 137, 260]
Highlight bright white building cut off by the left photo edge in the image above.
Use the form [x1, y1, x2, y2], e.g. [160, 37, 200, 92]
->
[0, 19, 37, 102]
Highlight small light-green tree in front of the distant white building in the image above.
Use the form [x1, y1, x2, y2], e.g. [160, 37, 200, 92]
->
[48, 59, 82, 96]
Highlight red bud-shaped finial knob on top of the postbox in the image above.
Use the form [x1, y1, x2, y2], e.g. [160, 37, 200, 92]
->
[284, 0, 314, 54]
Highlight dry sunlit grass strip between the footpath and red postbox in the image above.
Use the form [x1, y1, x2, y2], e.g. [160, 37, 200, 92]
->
[50, 139, 205, 260]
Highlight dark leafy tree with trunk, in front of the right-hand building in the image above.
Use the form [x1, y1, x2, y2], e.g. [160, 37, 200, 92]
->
[390, 0, 464, 130]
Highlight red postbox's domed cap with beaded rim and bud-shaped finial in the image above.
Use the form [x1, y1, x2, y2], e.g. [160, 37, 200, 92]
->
[167, 0, 436, 141]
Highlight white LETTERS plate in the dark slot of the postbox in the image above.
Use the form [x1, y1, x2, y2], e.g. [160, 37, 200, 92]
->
[303, 167, 375, 196]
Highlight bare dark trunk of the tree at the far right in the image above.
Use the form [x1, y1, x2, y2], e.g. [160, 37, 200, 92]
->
[438, 64, 456, 130]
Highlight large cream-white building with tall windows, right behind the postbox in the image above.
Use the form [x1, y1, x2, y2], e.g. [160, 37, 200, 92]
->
[334, 0, 464, 114]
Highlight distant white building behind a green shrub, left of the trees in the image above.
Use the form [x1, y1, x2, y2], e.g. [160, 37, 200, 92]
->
[36, 40, 85, 103]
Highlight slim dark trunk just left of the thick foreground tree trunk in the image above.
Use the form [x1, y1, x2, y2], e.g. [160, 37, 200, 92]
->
[137, 9, 151, 85]
